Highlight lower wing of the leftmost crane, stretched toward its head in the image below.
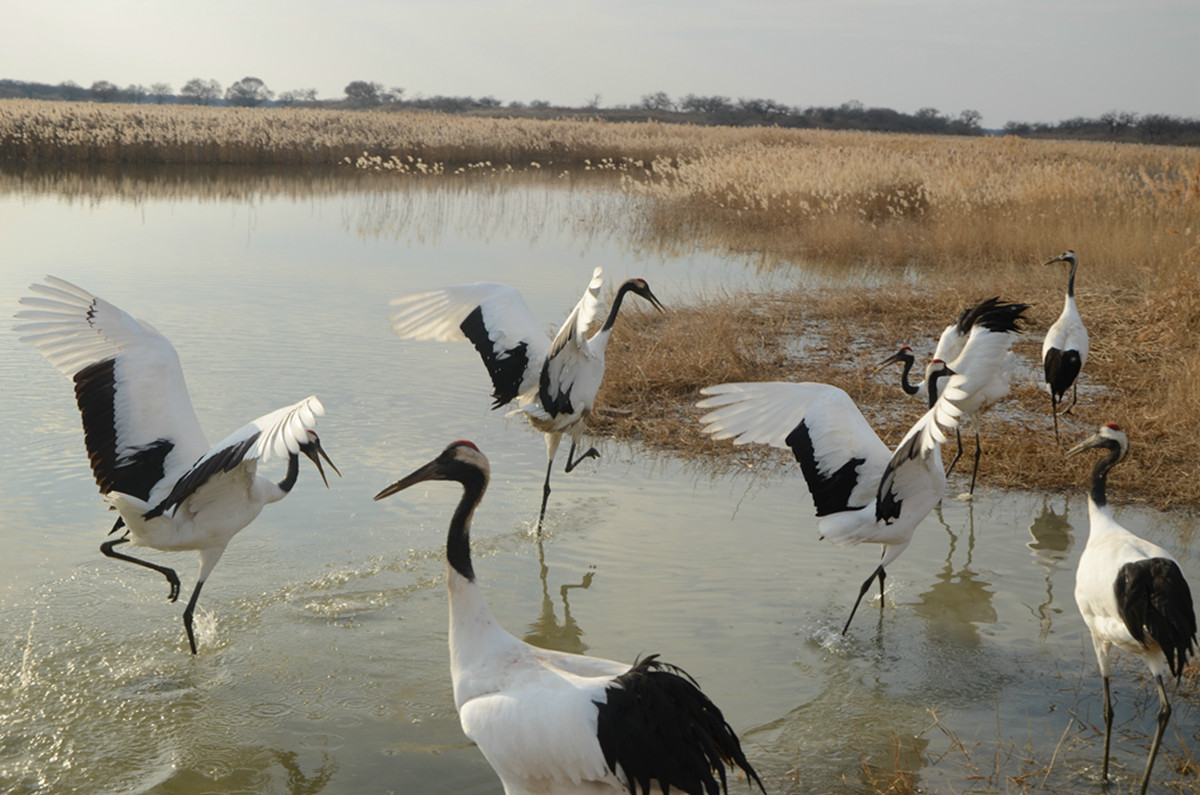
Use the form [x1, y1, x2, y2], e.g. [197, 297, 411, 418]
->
[146, 395, 325, 519]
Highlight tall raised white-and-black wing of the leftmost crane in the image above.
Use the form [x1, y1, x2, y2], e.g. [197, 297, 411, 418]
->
[16, 276, 209, 500]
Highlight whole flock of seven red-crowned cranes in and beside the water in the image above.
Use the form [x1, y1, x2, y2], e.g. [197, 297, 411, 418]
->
[16, 251, 1196, 795]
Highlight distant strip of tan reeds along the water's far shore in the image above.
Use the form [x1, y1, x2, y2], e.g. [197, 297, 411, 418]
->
[0, 100, 781, 173]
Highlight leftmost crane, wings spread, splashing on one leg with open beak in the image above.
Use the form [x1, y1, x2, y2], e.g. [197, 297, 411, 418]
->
[16, 276, 341, 654]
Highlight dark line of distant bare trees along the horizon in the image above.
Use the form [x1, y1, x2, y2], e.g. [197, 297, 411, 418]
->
[0, 77, 1200, 145]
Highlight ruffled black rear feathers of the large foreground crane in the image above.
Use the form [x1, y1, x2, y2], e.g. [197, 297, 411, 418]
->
[594, 654, 766, 795]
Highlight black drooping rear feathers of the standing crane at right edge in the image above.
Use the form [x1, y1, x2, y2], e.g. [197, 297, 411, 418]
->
[1114, 557, 1196, 679]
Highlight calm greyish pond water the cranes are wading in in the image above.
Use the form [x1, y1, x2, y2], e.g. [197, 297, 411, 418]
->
[0, 164, 1200, 794]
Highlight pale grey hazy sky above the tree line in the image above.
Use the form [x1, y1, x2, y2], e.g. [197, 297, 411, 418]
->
[0, 0, 1200, 127]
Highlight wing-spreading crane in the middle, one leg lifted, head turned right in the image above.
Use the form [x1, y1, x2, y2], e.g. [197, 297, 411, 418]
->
[390, 268, 664, 532]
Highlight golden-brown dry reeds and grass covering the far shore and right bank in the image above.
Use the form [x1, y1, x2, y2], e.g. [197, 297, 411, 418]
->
[0, 100, 1200, 507]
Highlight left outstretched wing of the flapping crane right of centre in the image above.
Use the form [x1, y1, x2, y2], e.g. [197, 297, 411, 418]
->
[697, 382, 892, 516]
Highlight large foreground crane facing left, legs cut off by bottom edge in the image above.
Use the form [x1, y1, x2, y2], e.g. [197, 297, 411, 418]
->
[376, 441, 766, 795]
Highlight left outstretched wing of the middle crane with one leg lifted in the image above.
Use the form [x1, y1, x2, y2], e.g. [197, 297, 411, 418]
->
[389, 282, 551, 406]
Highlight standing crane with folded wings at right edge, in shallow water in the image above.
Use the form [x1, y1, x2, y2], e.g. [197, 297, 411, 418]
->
[1067, 423, 1196, 795]
